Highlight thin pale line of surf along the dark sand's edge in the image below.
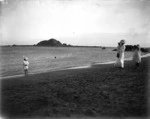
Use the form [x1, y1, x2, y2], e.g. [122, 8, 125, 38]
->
[0, 53, 150, 79]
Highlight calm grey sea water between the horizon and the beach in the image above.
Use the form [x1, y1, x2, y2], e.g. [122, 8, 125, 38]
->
[0, 46, 133, 77]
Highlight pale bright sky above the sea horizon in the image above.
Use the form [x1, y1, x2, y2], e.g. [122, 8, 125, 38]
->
[0, 0, 150, 47]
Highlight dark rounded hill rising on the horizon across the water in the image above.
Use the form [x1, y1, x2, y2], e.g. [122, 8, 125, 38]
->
[36, 38, 71, 47]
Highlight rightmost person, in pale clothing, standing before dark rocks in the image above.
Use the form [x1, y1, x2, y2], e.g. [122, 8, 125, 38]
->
[133, 45, 141, 69]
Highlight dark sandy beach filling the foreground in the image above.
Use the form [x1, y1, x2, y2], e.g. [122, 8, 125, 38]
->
[1, 57, 150, 118]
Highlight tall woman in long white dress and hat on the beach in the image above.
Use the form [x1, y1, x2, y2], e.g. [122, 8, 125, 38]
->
[115, 40, 125, 68]
